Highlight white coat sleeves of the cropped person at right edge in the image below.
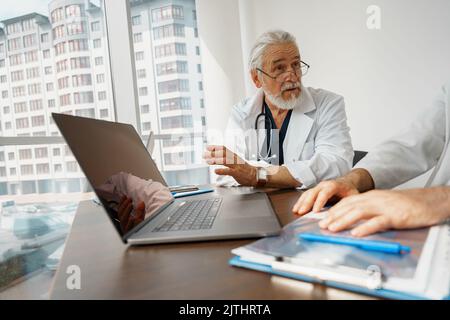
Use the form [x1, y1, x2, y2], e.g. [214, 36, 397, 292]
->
[355, 82, 450, 189]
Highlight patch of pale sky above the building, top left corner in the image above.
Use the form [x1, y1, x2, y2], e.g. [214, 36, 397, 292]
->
[0, 0, 51, 21]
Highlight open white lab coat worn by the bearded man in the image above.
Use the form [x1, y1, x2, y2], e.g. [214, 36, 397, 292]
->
[217, 86, 353, 187]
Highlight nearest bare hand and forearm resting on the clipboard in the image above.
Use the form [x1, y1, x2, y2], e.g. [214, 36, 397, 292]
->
[319, 187, 450, 237]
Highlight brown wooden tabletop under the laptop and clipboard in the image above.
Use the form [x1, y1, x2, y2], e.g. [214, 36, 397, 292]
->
[51, 188, 367, 299]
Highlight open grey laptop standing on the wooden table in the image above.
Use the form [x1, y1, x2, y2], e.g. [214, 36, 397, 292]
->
[52, 113, 281, 245]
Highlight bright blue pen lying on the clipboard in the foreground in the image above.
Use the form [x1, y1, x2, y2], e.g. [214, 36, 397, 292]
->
[298, 233, 411, 254]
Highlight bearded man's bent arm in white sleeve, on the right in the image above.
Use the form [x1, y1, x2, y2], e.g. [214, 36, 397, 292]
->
[284, 96, 353, 188]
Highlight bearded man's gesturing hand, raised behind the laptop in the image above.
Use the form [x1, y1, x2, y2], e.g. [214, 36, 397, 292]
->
[203, 145, 257, 187]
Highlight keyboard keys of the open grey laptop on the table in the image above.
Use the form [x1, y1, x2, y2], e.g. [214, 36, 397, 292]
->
[152, 198, 222, 232]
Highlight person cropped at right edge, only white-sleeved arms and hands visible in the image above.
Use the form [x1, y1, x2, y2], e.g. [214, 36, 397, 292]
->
[293, 82, 450, 236]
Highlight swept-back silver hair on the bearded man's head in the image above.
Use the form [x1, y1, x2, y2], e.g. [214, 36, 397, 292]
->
[248, 30, 297, 70]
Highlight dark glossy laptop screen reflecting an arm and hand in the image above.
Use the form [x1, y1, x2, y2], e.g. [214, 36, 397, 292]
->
[52, 113, 173, 240]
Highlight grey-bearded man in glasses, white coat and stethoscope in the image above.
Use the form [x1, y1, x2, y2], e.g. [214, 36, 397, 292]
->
[204, 31, 353, 188]
